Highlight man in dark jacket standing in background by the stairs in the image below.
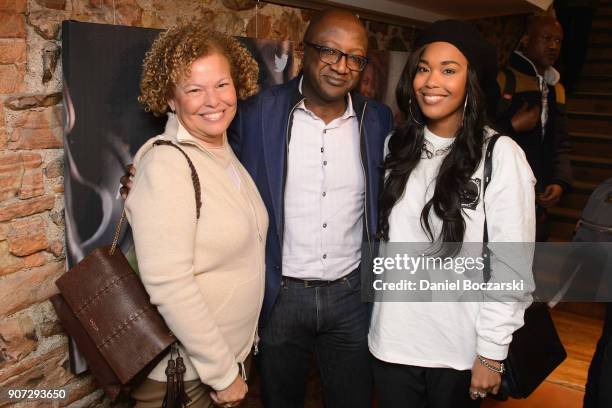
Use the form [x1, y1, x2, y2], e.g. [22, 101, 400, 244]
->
[495, 16, 572, 241]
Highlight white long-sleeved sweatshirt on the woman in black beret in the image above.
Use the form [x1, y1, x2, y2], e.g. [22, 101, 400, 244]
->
[368, 128, 535, 370]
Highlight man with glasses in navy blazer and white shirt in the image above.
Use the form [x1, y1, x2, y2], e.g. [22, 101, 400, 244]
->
[228, 10, 393, 408]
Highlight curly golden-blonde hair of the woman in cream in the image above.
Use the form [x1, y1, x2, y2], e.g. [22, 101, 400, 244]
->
[138, 20, 259, 115]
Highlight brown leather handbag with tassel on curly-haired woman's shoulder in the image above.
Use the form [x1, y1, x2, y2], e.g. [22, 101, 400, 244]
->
[51, 140, 201, 406]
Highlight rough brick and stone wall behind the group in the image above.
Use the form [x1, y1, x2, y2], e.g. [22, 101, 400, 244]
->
[0, 0, 413, 406]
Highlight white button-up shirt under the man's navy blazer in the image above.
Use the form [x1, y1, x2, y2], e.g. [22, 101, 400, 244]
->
[283, 78, 365, 280]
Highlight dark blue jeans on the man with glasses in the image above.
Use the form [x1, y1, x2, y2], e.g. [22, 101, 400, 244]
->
[257, 270, 372, 408]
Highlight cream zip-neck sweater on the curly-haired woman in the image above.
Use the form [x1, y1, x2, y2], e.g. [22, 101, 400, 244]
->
[125, 114, 268, 390]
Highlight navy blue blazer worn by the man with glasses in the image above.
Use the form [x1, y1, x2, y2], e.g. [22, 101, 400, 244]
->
[228, 76, 393, 324]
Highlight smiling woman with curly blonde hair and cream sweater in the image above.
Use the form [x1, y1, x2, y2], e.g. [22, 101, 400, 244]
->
[125, 21, 268, 407]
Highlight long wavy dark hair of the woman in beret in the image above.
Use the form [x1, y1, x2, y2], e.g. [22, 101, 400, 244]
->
[378, 45, 487, 256]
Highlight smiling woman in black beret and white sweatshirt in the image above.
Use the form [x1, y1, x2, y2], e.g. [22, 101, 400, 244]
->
[369, 20, 535, 408]
